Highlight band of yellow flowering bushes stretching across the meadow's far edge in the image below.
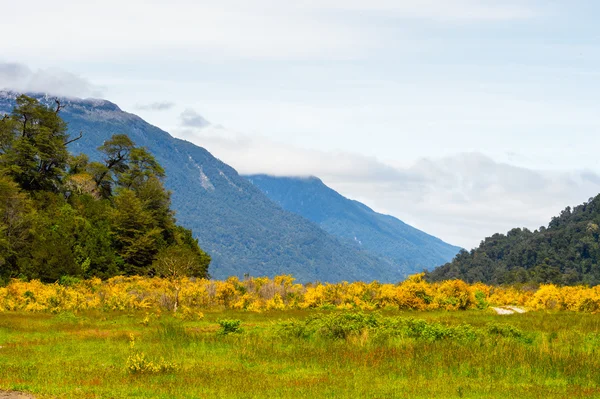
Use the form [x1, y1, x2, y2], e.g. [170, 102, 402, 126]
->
[0, 274, 600, 319]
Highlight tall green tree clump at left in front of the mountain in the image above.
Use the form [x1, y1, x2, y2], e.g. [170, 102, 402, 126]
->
[0, 95, 210, 282]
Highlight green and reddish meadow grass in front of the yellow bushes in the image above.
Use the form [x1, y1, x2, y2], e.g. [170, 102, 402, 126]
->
[0, 310, 600, 398]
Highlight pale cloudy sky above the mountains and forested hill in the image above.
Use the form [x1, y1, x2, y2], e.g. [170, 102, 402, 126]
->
[0, 0, 600, 248]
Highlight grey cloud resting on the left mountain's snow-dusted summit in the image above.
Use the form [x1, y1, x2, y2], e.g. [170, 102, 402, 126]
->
[0, 62, 102, 97]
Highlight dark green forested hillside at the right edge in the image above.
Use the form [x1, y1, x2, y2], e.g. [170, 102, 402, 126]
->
[427, 195, 600, 285]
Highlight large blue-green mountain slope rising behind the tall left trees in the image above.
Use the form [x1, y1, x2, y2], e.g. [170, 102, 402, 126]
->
[0, 91, 402, 282]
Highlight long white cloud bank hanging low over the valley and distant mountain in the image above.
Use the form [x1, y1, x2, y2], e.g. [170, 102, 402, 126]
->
[176, 126, 600, 248]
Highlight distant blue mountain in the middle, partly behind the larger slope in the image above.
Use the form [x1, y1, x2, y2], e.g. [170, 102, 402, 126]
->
[247, 175, 460, 275]
